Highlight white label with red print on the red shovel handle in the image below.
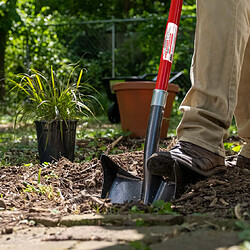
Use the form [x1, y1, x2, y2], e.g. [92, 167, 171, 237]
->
[163, 23, 178, 63]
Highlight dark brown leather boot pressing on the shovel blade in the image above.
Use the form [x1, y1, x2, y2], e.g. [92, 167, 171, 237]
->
[147, 141, 226, 177]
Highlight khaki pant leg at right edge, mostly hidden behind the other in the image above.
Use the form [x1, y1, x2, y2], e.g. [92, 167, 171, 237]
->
[235, 39, 250, 158]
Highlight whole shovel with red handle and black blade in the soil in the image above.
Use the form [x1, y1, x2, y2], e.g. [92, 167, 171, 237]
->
[100, 0, 183, 204]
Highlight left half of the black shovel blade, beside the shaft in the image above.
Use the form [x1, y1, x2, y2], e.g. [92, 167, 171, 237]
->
[100, 154, 142, 204]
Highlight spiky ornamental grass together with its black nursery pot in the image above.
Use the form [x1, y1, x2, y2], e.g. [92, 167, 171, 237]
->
[11, 65, 99, 163]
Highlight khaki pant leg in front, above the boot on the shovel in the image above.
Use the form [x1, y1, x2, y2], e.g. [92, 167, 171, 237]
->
[177, 0, 250, 156]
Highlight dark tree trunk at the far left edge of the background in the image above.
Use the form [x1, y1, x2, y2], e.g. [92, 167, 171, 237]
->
[0, 29, 7, 101]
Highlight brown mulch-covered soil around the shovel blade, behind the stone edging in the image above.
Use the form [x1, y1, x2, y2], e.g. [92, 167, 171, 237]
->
[0, 138, 250, 231]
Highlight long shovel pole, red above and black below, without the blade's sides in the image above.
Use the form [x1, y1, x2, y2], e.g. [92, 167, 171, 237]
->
[142, 0, 183, 204]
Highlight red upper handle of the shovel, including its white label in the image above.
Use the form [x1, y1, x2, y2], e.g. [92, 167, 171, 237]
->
[155, 0, 183, 91]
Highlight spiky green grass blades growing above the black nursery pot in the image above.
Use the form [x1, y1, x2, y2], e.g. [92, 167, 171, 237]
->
[10, 65, 100, 125]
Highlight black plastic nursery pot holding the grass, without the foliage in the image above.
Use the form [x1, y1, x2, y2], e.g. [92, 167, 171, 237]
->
[35, 120, 77, 163]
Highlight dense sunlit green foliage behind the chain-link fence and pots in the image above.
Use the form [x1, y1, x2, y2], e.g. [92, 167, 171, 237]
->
[0, 0, 196, 114]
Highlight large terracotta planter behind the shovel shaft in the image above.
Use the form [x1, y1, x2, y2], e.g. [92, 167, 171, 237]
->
[112, 81, 179, 138]
